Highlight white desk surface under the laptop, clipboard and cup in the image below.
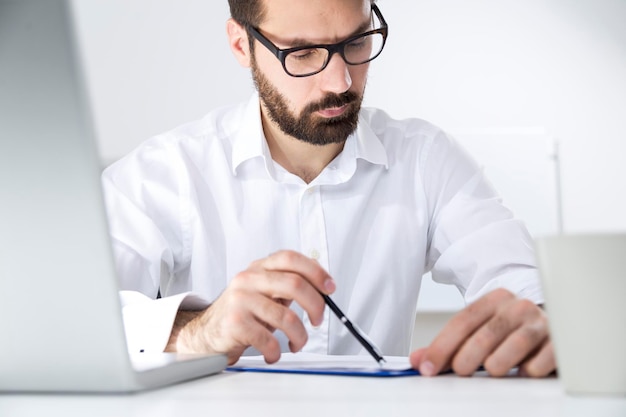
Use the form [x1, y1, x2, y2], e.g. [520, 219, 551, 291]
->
[0, 372, 626, 417]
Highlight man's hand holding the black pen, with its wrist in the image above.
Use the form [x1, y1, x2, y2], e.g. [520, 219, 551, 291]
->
[166, 251, 335, 364]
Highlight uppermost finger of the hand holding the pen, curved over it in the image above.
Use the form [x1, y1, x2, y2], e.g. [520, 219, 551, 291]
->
[260, 250, 336, 294]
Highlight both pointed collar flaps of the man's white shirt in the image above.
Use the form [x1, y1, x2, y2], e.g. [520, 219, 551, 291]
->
[232, 93, 389, 175]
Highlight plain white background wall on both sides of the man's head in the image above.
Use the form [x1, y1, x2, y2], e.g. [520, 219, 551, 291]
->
[76, 0, 626, 232]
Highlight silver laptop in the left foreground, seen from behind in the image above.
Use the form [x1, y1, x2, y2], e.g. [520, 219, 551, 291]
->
[0, 0, 226, 392]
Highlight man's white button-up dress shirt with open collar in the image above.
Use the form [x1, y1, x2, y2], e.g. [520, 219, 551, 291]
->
[103, 95, 543, 355]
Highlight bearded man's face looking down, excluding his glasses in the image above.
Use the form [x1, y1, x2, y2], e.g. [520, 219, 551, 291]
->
[251, 0, 370, 145]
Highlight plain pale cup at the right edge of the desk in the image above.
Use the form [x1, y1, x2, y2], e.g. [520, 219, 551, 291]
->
[535, 234, 626, 395]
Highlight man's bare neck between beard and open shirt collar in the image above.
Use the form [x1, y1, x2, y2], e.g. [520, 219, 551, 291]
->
[262, 109, 344, 184]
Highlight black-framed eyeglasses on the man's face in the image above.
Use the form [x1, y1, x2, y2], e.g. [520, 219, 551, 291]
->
[246, 4, 388, 77]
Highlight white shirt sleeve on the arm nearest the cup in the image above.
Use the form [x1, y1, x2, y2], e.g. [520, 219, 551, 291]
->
[423, 128, 543, 303]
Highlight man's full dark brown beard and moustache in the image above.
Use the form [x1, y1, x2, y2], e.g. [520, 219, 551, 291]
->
[251, 59, 363, 146]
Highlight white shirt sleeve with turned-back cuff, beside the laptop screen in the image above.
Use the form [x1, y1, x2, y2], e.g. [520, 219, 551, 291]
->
[102, 140, 201, 353]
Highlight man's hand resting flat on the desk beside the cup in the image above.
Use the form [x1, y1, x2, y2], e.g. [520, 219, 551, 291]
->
[410, 289, 556, 377]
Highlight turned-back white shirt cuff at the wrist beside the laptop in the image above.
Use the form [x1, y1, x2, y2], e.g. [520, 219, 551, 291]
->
[120, 291, 210, 353]
